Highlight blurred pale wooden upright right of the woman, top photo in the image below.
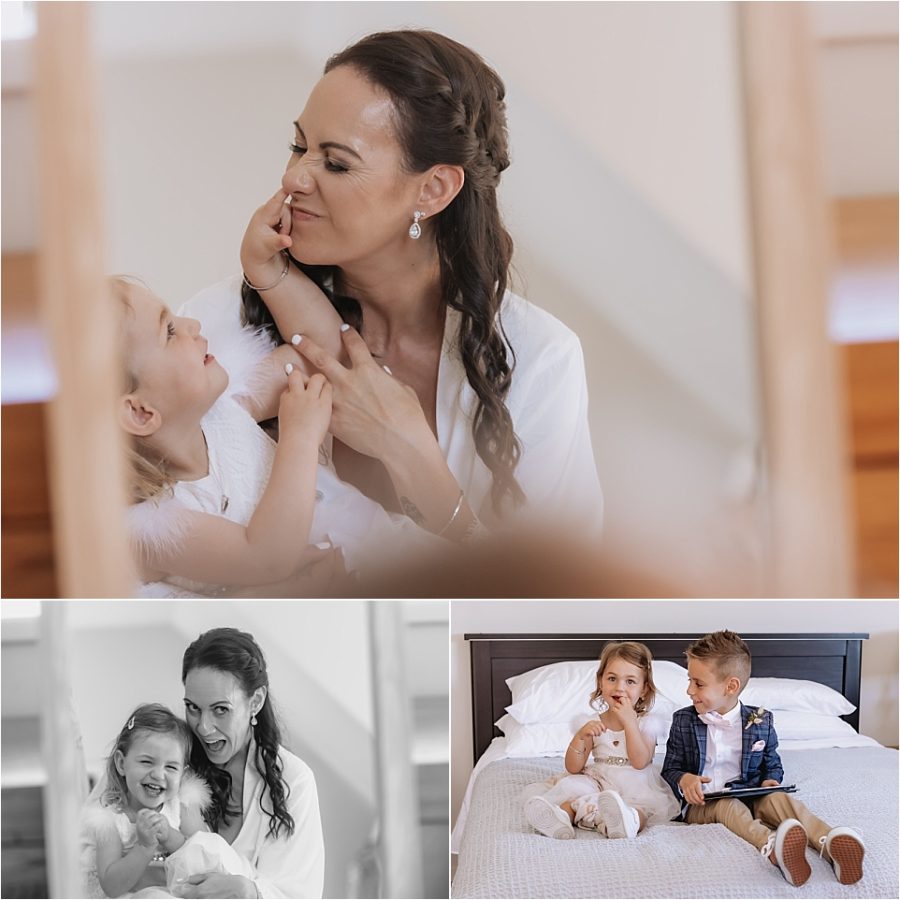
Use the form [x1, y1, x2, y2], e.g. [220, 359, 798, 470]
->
[737, 3, 853, 597]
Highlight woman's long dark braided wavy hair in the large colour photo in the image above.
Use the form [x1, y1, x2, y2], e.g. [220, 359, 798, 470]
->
[244, 30, 525, 510]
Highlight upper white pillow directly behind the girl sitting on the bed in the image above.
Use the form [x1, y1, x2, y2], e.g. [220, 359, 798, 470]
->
[506, 659, 688, 725]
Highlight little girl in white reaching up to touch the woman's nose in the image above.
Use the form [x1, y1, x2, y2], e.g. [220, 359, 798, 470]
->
[119, 195, 444, 596]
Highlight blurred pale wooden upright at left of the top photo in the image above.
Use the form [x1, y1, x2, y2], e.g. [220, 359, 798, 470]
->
[35, 3, 135, 597]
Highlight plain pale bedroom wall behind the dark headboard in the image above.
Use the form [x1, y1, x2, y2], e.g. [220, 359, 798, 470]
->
[450, 600, 898, 823]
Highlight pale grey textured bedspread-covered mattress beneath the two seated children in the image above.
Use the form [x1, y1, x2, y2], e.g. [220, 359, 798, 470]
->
[451, 747, 900, 900]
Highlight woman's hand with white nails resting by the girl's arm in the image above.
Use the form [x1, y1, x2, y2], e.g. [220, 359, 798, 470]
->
[296, 327, 434, 462]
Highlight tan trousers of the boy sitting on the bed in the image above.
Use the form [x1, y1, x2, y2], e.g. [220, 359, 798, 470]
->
[684, 791, 831, 857]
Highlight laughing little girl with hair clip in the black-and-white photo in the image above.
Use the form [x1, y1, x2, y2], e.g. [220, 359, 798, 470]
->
[81, 703, 210, 897]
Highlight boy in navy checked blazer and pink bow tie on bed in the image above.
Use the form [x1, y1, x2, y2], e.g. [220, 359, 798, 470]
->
[662, 631, 865, 886]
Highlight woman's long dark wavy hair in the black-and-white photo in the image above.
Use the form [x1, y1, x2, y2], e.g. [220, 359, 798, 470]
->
[181, 628, 294, 838]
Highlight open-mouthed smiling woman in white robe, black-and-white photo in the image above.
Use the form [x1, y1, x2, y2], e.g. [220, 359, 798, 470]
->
[180, 628, 324, 898]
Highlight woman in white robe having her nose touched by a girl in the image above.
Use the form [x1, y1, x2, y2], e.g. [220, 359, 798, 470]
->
[184, 30, 603, 556]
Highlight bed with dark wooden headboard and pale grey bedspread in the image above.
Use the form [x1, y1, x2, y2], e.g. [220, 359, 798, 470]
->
[452, 634, 898, 898]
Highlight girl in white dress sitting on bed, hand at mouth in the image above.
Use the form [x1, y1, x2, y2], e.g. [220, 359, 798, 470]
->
[525, 641, 678, 838]
